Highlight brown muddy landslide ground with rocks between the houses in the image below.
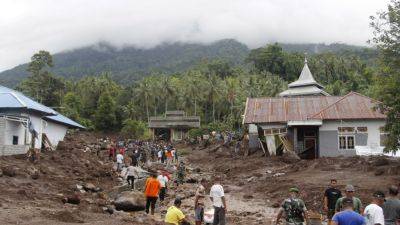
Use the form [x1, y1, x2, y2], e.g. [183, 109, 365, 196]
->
[0, 132, 400, 225]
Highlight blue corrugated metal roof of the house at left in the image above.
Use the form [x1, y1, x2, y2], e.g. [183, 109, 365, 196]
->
[0, 85, 85, 128]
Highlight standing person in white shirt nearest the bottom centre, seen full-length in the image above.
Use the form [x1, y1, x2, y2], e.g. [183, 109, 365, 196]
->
[210, 177, 227, 225]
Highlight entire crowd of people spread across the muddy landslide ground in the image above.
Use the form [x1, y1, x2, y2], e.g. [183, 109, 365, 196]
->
[97, 135, 400, 225]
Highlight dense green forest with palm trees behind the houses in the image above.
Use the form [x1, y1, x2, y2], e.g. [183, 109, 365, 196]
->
[7, 1, 400, 150]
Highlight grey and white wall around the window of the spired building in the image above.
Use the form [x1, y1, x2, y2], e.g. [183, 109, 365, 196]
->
[319, 120, 385, 157]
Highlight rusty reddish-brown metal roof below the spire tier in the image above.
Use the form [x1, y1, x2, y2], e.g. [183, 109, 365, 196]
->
[244, 92, 386, 124]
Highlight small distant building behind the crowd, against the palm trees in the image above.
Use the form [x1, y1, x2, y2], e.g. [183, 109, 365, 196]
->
[149, 111, 200, 142]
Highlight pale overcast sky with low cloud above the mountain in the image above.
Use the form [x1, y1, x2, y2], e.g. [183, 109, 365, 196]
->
[0, 0, 388, 71]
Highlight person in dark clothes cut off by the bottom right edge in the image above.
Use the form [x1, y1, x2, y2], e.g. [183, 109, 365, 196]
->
[382, 186, 400, 225]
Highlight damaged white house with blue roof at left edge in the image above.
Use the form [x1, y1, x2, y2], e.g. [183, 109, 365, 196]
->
[0, 86, 84, 156]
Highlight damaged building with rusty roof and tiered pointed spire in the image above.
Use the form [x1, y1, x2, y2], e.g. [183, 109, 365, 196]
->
[243, 60, 386, 159]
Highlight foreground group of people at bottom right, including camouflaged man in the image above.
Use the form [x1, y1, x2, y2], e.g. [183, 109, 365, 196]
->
[276, 179, 400, 225]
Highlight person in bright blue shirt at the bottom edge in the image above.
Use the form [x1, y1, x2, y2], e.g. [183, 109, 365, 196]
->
[332, 198, 366, 225]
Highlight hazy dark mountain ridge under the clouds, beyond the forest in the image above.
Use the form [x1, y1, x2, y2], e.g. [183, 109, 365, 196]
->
[0, 39, 250, 87]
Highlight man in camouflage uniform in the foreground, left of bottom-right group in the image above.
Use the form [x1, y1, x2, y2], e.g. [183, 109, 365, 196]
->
[276, 188, 307, 225]
